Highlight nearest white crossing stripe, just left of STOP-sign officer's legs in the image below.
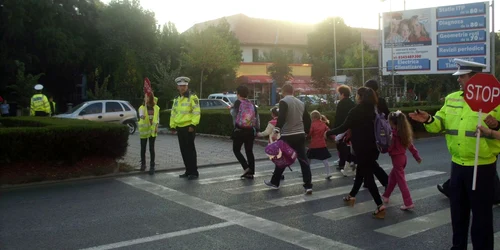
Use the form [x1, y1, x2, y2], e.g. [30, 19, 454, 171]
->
[375, 208, 451, 238]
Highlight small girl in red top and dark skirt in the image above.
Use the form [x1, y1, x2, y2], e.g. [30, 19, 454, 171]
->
[307, 110, 332, 180]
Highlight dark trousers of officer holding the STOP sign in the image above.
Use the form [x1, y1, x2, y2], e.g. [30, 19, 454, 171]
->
[450, 162, 496, 250]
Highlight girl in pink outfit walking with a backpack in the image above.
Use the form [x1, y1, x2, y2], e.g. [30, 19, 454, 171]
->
[382, 110, 422, 210]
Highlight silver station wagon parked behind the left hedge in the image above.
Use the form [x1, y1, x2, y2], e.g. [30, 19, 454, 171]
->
[54, 100, 137, 134]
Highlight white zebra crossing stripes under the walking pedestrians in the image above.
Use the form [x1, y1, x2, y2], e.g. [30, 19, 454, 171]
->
[137, 163, 500, 250]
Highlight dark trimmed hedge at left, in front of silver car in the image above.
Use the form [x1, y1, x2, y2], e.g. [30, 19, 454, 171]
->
[0, 117, 129, 163]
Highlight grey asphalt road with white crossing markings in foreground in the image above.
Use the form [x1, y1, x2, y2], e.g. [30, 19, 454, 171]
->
[0, 138, 500, 250]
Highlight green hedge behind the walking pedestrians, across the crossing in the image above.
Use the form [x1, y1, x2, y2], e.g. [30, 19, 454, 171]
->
[160, 106, 441, 136]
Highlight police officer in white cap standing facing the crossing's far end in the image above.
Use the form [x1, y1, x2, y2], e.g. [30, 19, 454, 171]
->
[170, 76, 200, 180]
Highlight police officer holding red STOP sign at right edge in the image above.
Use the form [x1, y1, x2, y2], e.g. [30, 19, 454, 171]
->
[410, 59, 500, 250]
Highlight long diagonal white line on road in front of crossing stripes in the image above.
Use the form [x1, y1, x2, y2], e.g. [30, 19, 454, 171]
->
[117, 177, 358, 250]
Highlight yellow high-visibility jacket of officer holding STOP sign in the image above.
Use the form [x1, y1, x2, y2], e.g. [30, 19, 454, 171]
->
[424, 91, 500, 166]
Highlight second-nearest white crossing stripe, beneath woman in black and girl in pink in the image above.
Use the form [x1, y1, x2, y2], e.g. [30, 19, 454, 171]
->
[314, 186, 437, 221]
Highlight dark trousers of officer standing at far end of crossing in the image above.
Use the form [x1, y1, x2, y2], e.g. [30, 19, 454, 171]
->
[177, 126, 198, 176]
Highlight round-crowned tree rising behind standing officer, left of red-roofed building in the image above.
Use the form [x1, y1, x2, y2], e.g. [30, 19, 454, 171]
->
[182, 20, 242, 98]
